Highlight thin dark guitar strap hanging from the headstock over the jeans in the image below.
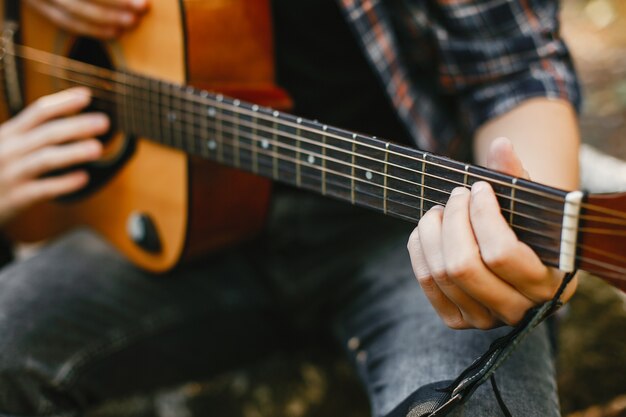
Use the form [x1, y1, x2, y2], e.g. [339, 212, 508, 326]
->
[386, 271, 576, 417]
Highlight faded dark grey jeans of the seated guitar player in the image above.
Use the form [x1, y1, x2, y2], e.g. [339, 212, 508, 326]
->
[0, 190, 559, 417]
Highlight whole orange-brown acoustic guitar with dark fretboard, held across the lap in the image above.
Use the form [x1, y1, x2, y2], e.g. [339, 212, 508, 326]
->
[0, 0, 626, 291]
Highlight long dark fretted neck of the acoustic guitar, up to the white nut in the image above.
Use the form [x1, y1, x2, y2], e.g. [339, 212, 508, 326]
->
[117, 75, 568, 266]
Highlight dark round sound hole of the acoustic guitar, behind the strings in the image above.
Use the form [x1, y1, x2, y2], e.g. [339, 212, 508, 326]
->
[69, 37, 117, 144]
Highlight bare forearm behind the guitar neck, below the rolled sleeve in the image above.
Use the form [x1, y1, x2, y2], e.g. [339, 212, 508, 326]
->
[474, 98, 580, 189]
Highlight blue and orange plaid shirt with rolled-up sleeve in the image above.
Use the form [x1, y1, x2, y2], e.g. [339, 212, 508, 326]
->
[339, 0, 581, 156]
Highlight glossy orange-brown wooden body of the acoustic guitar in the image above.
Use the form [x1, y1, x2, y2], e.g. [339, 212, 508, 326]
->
[0, 0, 288, 272]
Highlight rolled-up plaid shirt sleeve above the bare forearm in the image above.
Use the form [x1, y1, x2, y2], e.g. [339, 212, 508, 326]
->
[430, 0, 581, 131]
